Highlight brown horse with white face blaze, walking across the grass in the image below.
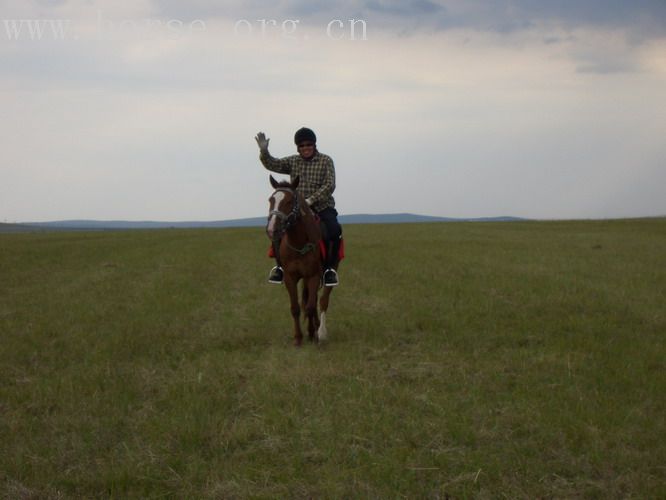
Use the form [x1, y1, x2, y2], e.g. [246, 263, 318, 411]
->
[266, 176, 332, 346]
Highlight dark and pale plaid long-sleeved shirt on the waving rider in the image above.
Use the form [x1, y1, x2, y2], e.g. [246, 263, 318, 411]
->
[259, 151, 335, 212]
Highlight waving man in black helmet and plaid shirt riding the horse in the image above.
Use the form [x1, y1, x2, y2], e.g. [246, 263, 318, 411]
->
[255, 127, 342, 286]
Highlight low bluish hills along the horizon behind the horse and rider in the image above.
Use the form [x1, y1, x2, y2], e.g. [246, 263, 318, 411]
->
[7, 213, 525, 232]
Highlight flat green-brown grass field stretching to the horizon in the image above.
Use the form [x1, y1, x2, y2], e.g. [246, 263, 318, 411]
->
[0, 219, 666, 499]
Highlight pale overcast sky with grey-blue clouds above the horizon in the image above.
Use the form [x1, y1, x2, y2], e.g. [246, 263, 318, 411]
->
[0, 0, 666, 222]
